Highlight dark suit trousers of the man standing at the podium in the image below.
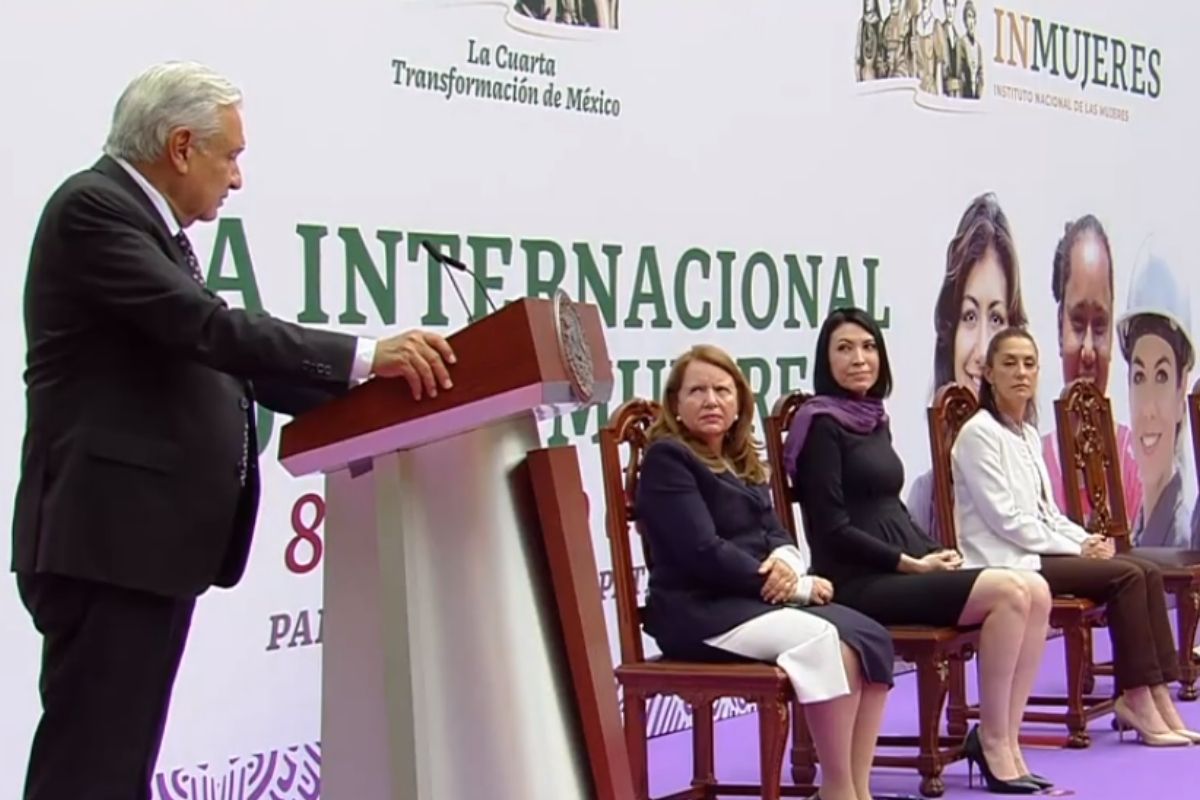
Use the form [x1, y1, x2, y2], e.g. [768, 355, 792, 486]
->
[17, 575, 196, 800]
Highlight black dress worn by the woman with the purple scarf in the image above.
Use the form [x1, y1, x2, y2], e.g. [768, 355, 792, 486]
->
[792, 415, 982, 625]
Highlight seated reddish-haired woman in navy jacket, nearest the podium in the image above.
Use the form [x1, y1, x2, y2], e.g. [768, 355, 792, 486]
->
[635, 345, 894, 800]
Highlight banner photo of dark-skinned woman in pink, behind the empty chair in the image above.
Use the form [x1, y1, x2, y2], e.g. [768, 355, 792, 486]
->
[1042, 213, 1141, 519]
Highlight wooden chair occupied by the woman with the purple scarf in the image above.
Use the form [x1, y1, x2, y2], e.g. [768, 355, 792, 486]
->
[766, 391, 979, 798]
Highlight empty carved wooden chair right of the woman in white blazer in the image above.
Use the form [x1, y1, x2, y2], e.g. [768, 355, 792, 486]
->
[1055, 379, 1200, 700]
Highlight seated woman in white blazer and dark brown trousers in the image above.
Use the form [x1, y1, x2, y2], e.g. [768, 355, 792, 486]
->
[952, 327, 1200, 746]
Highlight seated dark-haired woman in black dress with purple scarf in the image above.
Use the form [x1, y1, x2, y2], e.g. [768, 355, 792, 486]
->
[784, 308, 1050, 794]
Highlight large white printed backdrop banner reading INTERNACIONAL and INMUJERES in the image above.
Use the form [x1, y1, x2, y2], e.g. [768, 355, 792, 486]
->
[0, 0, 1200, 800]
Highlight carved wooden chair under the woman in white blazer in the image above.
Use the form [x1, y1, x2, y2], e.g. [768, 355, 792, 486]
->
[929, 384, 1112, 747]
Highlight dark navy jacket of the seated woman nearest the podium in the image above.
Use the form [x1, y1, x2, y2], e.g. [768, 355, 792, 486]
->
[634, 439, 794, 658]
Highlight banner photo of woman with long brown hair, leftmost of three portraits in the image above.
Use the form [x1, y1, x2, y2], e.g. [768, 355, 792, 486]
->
[907, 192, 1028, 537]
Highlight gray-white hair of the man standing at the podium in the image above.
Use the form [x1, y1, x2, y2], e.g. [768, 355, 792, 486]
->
[104, 61, 241, 163]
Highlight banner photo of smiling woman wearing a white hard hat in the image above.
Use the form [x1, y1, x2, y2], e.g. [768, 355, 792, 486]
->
[1117, 241, 1200, 548]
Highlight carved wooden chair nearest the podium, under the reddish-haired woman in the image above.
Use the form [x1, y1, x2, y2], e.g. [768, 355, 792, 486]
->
[600, 398, 814, 800]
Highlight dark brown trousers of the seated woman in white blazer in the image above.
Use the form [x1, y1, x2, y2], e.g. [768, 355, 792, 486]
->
[1042, 554, 1180, 691]
